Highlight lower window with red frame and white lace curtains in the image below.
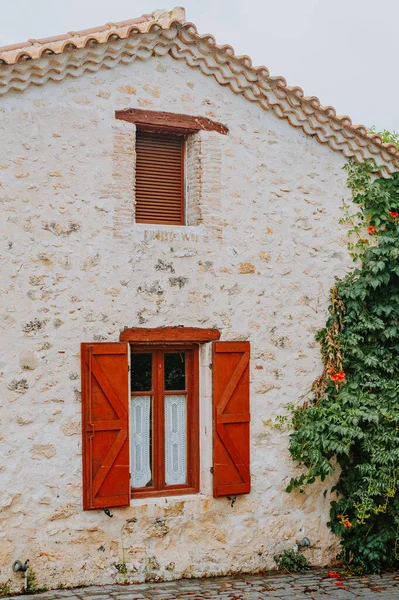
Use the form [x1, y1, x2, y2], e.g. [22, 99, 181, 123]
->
[130, 346, 199, 497]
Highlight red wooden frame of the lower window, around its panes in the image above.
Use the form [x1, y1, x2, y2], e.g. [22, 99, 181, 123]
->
[129, 342, 200, 499]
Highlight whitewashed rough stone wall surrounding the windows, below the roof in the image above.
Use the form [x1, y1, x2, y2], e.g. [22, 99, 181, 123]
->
[0, 56, 350, 589]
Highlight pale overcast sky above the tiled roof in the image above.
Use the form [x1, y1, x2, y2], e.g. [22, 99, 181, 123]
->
[0, 0, 399, 131]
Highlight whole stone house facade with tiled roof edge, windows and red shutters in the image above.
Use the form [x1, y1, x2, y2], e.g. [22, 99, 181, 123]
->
[0, 8, 399, 589]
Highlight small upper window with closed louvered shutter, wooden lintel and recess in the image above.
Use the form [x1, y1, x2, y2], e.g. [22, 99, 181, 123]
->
[115, 108, 228, 225]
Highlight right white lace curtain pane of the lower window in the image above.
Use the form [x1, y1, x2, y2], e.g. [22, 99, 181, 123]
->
[165, 394, 187, 485]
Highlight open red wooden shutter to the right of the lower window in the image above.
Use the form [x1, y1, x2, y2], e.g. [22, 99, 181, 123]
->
[213, 342, 251, 497]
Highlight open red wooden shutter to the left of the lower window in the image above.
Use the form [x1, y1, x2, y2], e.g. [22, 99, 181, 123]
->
[81, 342, 130, 510]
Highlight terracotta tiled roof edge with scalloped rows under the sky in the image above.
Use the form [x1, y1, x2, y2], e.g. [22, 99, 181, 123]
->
[0, 7, 399, 176]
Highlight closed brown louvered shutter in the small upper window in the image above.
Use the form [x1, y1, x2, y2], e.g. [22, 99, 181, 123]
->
[136, 130, 184, 225]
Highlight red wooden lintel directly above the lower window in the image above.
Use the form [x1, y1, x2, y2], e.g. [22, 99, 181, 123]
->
[119, 327, 220, 344]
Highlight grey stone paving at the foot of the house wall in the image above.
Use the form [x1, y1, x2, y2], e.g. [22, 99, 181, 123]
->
[7, 569, 399, 600]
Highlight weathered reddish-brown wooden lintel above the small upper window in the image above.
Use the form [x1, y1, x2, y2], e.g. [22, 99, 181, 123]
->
[115, 108, 229, 135]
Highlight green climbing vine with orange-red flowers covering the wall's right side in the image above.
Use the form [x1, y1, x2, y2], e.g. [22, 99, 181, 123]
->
[287, 132, 399, 573]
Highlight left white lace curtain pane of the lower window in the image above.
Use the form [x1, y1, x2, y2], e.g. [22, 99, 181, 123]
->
[130, 396, 152, 488]
